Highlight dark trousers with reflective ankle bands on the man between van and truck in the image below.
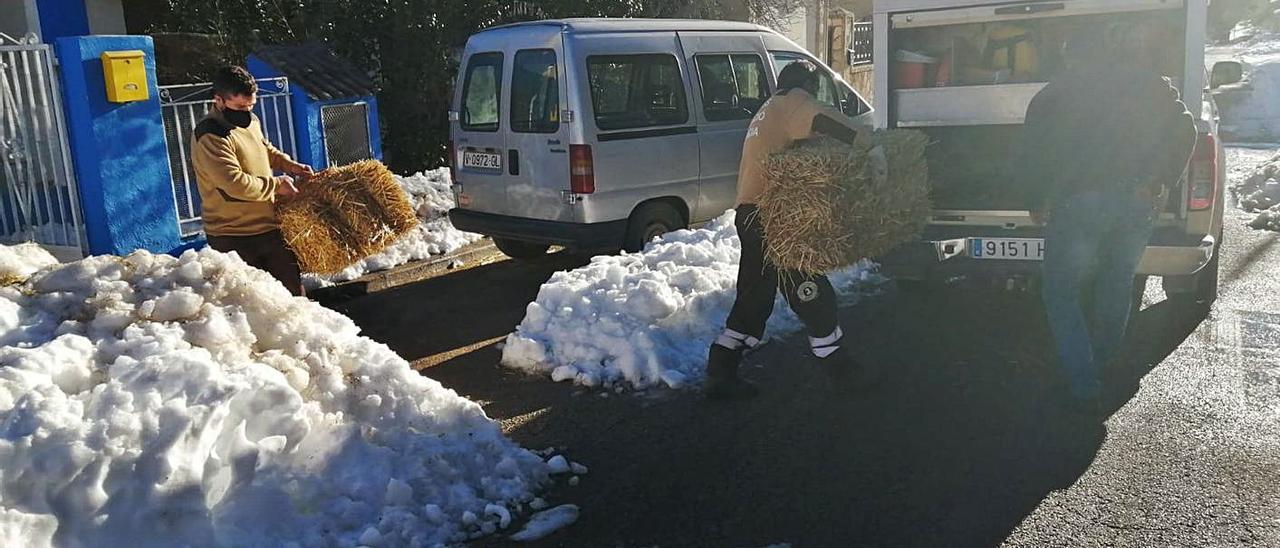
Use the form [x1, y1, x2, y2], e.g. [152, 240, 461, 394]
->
[712, 205, 841, 357]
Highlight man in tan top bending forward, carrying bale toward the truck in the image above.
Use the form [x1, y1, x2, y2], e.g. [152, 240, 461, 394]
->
[705, 60, 863, 399]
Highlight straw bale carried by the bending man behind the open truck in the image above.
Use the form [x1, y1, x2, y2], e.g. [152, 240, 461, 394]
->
[756, 131, 932, 274]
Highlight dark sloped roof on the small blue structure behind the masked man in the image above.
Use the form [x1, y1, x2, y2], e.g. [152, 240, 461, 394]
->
[253, 42, 376, 101]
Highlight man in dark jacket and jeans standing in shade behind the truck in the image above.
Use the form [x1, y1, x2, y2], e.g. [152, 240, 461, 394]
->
[1018, 26, 1196, 414]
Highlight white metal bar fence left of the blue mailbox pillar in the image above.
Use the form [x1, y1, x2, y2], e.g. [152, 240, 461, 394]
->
[0, 35, 86, 256]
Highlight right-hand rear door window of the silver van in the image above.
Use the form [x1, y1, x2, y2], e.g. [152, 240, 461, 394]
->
[511, 50, 559, 133]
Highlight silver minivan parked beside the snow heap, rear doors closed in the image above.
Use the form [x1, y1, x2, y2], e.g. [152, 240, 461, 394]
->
[449, 19, 870, 259]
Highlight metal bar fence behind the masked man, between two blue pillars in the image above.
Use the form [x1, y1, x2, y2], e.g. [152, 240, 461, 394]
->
[160, 78, 297, 237]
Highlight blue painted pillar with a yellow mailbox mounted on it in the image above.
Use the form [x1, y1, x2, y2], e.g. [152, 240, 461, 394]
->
[56, 36, 183, 255]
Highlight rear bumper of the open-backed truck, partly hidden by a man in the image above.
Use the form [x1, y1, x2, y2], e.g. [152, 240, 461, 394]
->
[879, 232, 1217, 280]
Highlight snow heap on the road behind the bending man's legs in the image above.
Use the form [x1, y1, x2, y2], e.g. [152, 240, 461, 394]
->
[502, 211, 878, 389]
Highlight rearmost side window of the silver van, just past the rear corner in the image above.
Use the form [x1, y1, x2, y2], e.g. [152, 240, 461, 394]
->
[586, 54, 689, 131]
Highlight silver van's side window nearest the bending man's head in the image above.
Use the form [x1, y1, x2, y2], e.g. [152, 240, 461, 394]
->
[694, 55, 769, 122]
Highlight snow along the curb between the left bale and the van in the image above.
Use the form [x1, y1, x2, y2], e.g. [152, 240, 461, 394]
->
[303, 168, 481, 288]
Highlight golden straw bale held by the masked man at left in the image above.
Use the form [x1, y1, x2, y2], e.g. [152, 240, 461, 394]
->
[275, 160, 417, 274]
